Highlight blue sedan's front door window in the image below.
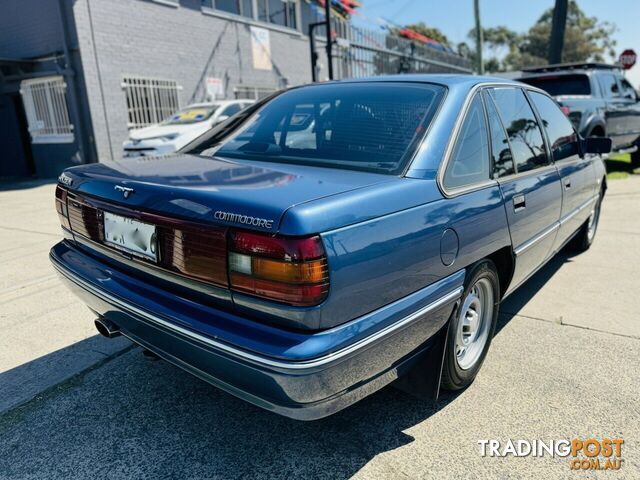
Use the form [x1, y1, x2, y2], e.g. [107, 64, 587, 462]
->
[529, 92, 580, 161]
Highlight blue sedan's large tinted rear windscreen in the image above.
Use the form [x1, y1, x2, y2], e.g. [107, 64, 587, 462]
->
[202, 82, 445, 174]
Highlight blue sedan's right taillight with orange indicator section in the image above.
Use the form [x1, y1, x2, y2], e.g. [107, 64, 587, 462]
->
[229, 231, 329, 306]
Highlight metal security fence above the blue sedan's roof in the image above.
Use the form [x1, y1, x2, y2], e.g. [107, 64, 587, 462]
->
[334, 21, 472, 78]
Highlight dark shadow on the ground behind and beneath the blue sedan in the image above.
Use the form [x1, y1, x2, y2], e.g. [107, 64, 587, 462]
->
[0, 251, 572, 478]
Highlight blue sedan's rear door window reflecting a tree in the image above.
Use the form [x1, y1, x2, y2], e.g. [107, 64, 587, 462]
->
[489, 87, 549, 173]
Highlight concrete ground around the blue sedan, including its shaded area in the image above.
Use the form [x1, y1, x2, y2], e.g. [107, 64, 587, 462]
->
[0, 177, 640, 479]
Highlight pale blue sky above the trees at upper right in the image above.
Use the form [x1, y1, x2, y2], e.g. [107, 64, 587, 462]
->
[353, 0, 640, 88]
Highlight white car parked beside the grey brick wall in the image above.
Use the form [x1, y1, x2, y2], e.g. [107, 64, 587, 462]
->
[122, 100, 254, 157]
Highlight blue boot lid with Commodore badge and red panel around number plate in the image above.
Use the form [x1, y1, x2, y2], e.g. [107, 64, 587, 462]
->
[61, 155, 393, 288]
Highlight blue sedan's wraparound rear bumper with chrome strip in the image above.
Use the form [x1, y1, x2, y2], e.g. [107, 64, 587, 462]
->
[50, 241, 464, 420]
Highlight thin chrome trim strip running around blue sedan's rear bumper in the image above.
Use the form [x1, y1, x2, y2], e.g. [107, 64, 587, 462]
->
[50, 256, 464, 371]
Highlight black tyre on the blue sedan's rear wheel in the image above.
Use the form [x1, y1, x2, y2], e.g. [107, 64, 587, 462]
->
[441, 259, 500, 391]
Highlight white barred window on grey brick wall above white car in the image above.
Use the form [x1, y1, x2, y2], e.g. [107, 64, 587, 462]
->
[122, 76, 182, 129]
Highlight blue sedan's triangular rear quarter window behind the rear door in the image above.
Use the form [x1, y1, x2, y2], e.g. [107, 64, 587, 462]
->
[443, 95, 491, 189]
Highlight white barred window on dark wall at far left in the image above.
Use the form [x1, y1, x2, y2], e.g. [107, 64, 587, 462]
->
[20, 76, 73, 143]
